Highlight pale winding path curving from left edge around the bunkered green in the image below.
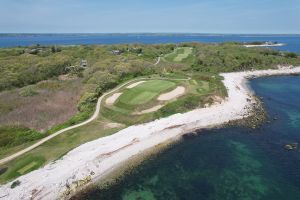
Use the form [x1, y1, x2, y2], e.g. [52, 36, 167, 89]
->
[0, 73, 191, 165]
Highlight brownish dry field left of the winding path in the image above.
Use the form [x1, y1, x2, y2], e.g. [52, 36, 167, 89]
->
[0, 79, 82, 131]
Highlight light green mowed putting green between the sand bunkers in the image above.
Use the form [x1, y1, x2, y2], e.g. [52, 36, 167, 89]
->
[116, 80, 176, 107]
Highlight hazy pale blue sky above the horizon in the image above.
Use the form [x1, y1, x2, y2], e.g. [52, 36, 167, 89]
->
[0, 0, 300, 33]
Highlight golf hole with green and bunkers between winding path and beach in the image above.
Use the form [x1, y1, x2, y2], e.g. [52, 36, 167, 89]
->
[0, 73, 217, 182]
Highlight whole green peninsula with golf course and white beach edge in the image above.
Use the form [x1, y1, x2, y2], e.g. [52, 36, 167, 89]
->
[0, 43, 300, 199]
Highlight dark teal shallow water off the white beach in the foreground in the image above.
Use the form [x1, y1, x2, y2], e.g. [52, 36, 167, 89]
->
[76, 76, 300, 200]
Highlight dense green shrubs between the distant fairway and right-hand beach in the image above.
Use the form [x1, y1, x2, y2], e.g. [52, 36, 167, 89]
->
[192, 43, 300, 73]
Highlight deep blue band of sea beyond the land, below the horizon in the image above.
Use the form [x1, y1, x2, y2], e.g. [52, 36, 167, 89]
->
[0, 34, 300, 53]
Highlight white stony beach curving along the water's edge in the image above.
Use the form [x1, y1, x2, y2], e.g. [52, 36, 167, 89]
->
[0, 67, 300, 199]
